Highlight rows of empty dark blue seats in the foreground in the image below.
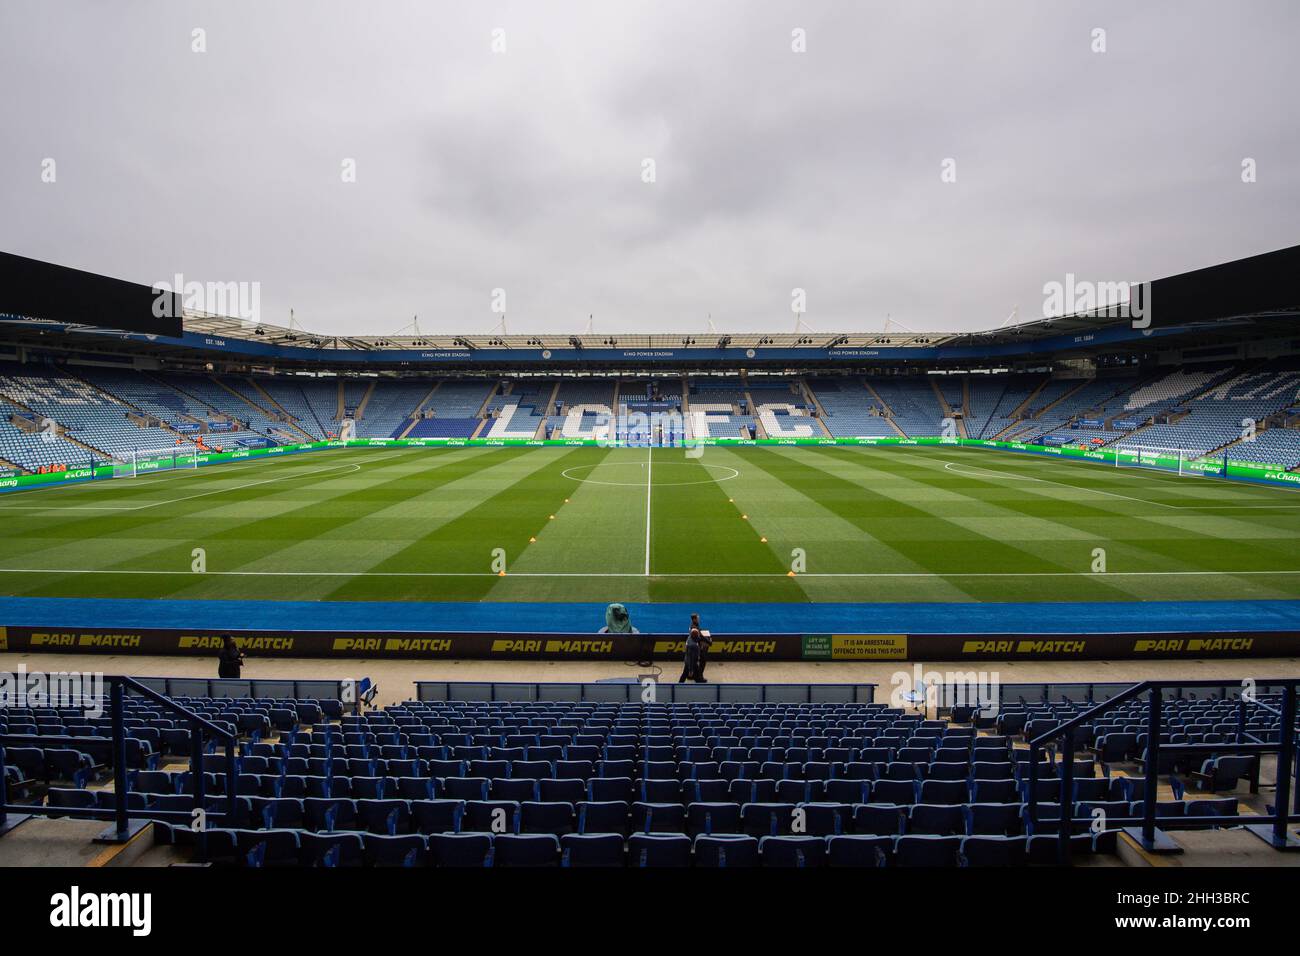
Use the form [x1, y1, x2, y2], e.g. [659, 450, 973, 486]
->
[0, 695, 1281, 868]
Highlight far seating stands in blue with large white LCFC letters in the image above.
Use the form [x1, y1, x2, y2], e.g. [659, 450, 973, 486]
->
[0, 360, 1300, 471]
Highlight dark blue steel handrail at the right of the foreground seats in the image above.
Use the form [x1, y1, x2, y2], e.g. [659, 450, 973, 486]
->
[1026, 678, 1300, 862]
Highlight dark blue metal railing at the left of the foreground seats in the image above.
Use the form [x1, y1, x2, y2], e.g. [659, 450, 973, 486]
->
[0, 676, 239, 843]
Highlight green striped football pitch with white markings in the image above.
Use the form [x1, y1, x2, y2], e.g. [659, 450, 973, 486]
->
[0, 446, 1300, 600]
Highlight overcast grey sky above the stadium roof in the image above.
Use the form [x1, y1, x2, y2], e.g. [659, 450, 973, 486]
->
[0, 0, 1300, 334]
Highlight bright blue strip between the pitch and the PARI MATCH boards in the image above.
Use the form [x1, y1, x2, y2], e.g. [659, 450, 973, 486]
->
[0, 597, 1300, 635]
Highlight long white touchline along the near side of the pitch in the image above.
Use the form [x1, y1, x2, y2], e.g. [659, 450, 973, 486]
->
[0, 567, 1300, 580]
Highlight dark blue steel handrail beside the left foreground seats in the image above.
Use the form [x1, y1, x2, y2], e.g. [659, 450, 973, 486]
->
[0, 675, 239, 842]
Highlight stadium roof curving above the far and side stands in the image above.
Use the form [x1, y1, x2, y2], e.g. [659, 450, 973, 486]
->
[0, 246, 1300, 371]
